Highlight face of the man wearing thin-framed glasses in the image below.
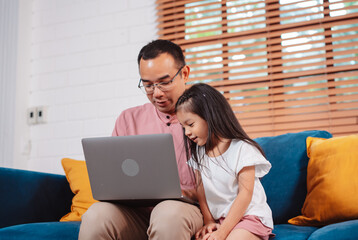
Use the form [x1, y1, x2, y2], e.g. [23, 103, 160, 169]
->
[139, 53, 190, 114]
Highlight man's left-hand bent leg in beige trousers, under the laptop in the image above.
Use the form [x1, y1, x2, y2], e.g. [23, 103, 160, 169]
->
[78, 202, 150, 240]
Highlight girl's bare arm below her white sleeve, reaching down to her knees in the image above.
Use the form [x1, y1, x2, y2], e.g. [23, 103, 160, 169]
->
[210, 166, 255, 239]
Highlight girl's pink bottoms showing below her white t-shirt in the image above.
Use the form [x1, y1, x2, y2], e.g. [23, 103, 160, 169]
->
[219, 215, 275, 240]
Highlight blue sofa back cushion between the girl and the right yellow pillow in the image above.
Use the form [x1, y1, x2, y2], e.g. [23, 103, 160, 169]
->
[255, 130, 332, 224]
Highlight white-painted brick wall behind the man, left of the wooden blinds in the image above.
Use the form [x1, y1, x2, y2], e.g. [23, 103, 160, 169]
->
[14, 0, 157, 173]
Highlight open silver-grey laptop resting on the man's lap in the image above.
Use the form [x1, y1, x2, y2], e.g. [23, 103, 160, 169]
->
[82, 134, 196, 206]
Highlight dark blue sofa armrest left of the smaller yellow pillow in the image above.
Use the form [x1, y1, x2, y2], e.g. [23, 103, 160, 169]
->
[0, 168, 74, 228]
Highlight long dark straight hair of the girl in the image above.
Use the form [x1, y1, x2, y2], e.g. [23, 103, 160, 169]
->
[175, 83, 265, 166]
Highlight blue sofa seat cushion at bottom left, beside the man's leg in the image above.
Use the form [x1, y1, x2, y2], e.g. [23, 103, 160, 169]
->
[0, 222, 81, 240]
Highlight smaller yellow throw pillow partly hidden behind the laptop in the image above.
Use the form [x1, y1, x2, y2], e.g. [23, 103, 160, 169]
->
[60, 158, 97, 222]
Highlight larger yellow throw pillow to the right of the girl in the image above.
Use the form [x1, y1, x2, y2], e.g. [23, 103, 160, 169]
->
[288, 134, 358, 226]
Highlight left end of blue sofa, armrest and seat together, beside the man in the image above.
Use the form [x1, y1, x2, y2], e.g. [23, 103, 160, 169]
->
[0, 168, 80, 240]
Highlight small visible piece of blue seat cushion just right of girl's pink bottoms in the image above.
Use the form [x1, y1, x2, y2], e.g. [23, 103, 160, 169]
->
[273, 224, 317, 240]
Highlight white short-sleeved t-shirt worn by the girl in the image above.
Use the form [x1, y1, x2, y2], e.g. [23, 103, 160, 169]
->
[188, 139, 273, 228]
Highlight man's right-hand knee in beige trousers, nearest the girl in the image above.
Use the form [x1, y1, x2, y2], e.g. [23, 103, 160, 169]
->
[148, 200, 203, 240]
